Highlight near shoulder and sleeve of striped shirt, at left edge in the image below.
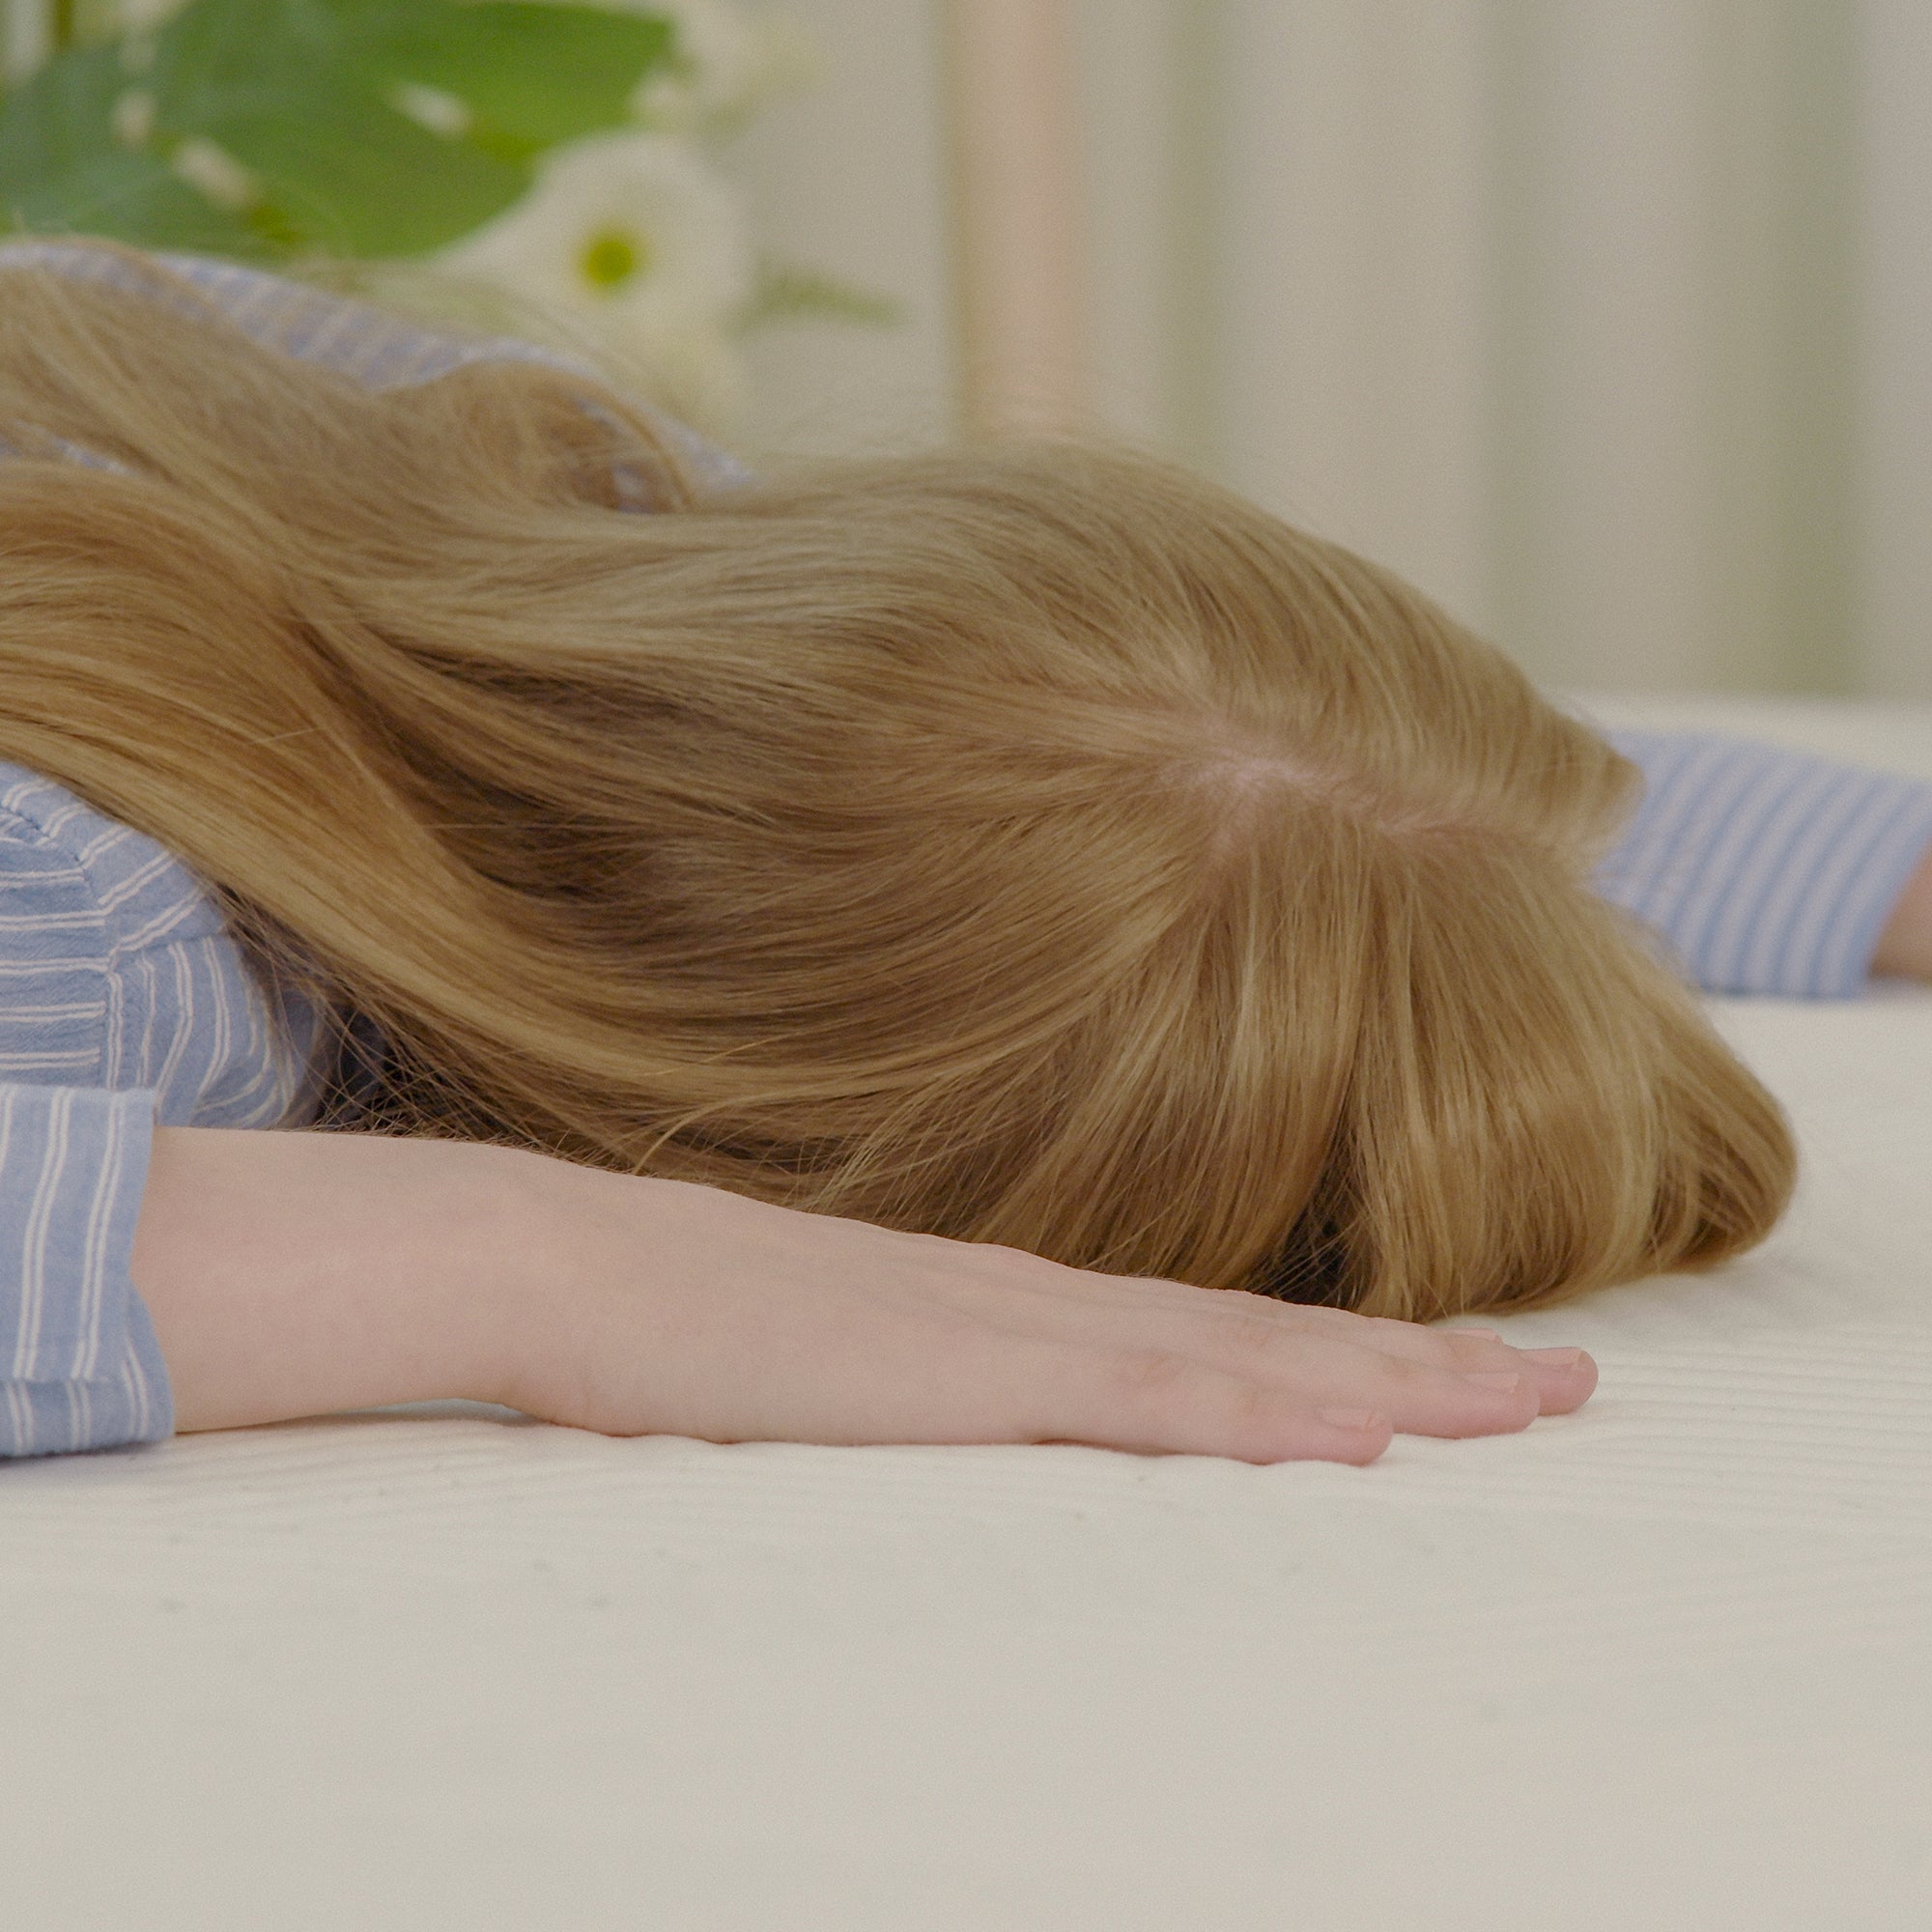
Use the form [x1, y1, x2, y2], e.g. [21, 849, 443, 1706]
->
[0, 763, 325, 1455]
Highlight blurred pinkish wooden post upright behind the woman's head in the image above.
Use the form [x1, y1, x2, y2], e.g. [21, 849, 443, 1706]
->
[945, 0, 1092, 435]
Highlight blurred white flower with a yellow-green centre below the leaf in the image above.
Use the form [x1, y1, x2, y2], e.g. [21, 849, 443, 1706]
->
[433, 131, 753, 429]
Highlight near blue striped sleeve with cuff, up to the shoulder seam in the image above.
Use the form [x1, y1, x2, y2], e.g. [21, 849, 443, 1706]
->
[0, 813, 174, 1457]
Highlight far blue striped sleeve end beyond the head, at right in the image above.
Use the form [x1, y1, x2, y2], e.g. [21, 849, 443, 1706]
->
[1596, 730, 1932, 999]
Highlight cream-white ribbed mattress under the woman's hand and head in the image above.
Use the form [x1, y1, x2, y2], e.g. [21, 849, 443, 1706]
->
[0, 701, 1932, 1932]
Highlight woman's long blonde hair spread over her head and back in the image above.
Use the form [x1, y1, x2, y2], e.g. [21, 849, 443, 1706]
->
[0, 242, 1793, 1320]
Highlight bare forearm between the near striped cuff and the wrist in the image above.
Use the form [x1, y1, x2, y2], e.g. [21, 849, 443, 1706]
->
[133, 1126, 537, 1430]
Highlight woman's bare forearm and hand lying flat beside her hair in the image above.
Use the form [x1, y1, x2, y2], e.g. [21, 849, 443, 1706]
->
[133, 1128, 1596, 1463]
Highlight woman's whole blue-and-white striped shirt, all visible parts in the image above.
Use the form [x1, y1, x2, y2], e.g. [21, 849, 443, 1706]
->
[0, 242, 1932, 1457]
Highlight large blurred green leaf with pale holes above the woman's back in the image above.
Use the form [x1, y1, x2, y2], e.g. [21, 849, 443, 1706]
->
[0, 0, 670, 257]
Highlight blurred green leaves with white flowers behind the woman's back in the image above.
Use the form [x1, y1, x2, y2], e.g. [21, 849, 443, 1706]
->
[0, 0, 895, 427]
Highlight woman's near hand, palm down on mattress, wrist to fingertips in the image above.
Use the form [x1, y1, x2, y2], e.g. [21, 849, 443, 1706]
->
[498, 1163, 1596, 1463]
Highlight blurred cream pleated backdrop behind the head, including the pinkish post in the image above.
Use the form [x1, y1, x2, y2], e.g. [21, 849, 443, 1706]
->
[8, 0, 1932, 697]
